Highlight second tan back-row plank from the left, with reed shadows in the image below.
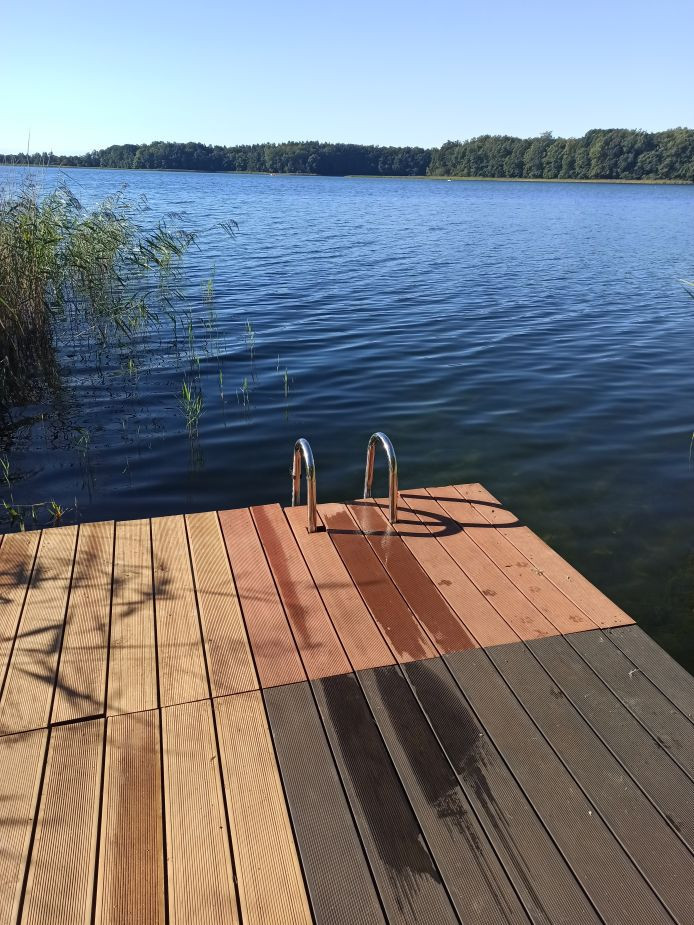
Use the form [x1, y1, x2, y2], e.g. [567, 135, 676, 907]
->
[0, 527, 77, 735]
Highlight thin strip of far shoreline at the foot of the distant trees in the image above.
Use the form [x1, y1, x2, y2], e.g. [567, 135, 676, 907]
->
[0, 162, 694, 186]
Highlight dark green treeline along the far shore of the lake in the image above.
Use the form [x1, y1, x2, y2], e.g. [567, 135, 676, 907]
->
[7, 128, 694, 182]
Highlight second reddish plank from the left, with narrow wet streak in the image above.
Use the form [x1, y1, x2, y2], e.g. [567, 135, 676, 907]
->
[251, 504, 352, 680]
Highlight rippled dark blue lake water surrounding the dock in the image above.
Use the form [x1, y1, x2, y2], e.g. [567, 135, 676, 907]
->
[0, 170, 694, 669]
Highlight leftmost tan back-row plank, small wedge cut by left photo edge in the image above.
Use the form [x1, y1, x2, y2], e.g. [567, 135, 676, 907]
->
[0, 530, 41, 690]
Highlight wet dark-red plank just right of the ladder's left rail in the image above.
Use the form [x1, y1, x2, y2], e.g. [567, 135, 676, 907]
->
[318, 504, 436, 662]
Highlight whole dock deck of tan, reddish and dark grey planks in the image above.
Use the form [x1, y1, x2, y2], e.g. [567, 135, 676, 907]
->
[0, 485, 694, 925]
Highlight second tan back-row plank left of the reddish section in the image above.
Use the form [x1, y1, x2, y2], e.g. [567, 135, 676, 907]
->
[152, 516, 209, 706]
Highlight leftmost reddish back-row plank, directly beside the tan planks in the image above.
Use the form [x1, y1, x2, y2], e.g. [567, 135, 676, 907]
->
[219, 509, 306, 687]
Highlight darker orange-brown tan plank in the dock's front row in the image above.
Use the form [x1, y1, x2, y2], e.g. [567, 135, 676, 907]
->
[96, 710, 165, 925]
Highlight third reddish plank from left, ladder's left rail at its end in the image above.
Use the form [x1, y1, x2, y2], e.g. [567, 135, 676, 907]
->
[284, 507, 395, 671]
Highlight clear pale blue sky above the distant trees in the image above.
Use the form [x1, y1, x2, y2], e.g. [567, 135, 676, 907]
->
[0, 0, 694, 153]
